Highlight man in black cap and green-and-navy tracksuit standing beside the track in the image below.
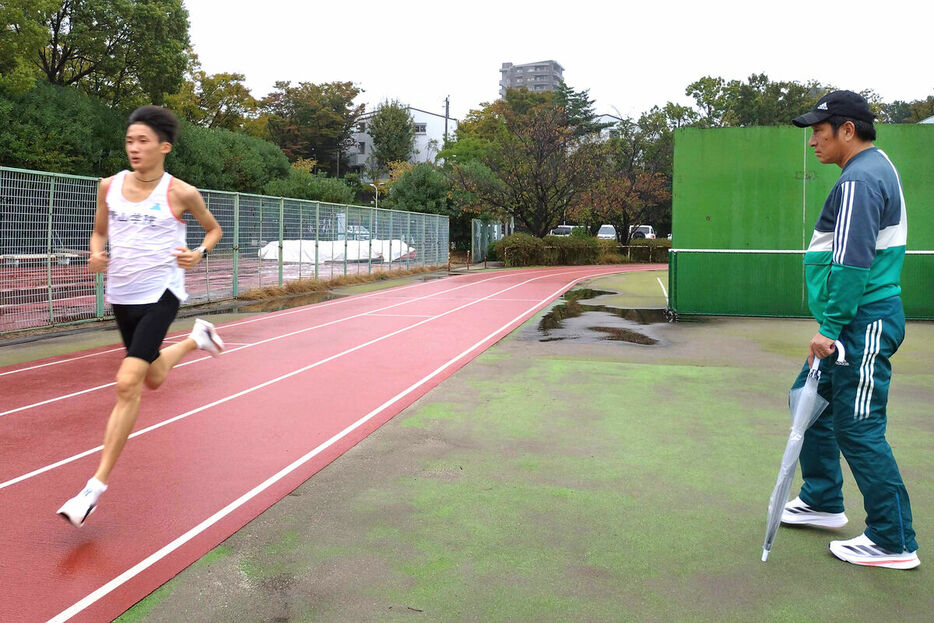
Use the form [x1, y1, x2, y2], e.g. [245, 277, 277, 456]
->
[782, 91, 921, 569]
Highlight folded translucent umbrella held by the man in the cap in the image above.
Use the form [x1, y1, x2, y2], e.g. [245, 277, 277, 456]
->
[762, 340, 847, 562]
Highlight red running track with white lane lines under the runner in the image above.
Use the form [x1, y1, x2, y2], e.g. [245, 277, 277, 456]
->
[0, 265, 657, 621]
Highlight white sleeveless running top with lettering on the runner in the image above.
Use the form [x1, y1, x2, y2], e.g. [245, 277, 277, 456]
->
[106, 171, 188, 305]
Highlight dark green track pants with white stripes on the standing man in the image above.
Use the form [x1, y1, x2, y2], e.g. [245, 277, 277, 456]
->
[793, 296, 918, 552]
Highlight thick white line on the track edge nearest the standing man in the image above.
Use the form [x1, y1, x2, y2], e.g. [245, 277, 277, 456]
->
[49, 266, 612, 623]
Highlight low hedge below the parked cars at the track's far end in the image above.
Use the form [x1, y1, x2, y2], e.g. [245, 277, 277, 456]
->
[488, 233, 671, 266]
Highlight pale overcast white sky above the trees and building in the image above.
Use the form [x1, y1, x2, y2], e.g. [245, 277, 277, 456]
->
[184, 0, 934, 119]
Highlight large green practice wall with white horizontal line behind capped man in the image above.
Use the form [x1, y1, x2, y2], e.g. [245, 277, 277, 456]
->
[669, 124, 934, 318]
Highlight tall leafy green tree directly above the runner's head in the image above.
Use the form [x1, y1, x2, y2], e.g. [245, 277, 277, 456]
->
[35, 0, 188, 109]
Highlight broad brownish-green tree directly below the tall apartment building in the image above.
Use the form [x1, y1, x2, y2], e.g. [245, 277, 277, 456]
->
[451, 89, 604, 236]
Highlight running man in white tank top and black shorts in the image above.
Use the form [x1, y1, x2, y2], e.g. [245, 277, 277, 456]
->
[58, 106, 224, 528]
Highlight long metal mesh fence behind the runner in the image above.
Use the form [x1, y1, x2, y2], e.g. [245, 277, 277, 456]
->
[0, 167, 449, 334]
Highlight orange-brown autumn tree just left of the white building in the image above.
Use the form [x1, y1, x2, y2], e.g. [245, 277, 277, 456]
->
[262, 82, 364, 177]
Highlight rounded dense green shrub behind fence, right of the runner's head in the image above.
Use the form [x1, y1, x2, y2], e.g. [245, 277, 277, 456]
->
[166, 123, 289, 193]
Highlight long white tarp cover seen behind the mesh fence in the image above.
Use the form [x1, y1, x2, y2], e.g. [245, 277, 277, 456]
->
[259, 240, 415, 264]
